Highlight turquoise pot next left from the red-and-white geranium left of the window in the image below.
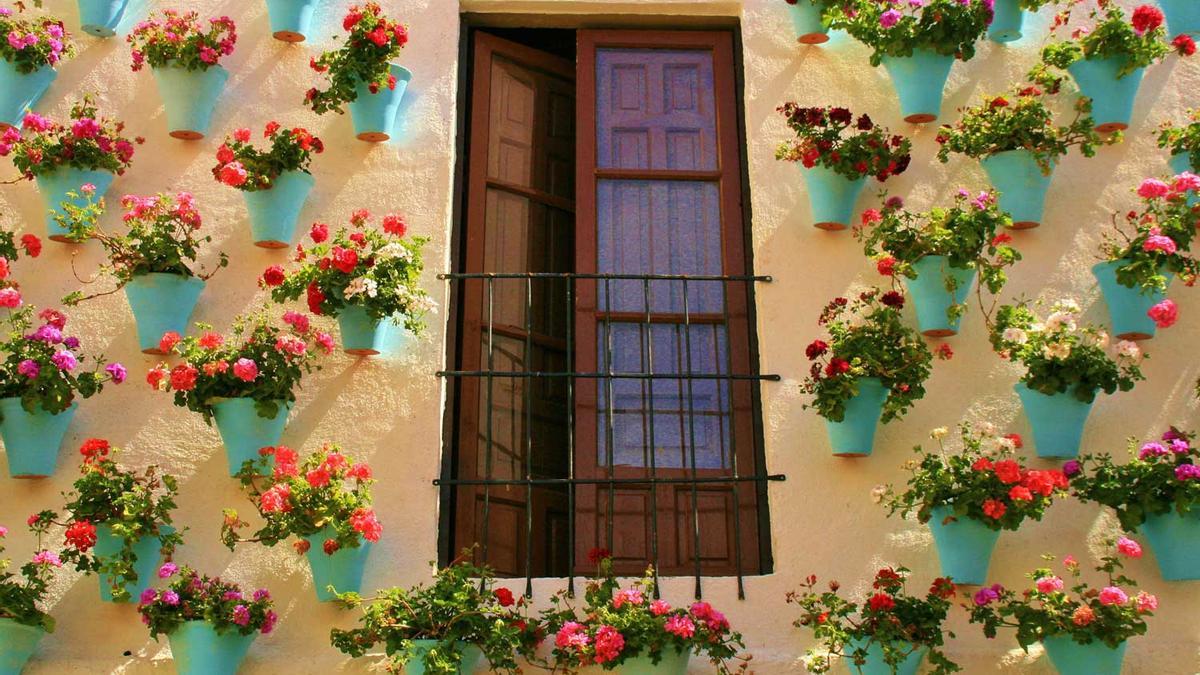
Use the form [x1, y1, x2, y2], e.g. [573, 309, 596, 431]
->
[125, 273, 204, 354]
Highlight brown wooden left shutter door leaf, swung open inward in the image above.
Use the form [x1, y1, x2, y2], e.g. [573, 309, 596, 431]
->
[455, 31, 575, 577]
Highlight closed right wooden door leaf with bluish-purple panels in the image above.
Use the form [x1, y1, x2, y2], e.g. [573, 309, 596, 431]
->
[576, 30, 758, 575]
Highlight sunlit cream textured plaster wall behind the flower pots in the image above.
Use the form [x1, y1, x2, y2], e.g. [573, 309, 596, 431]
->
[0, 0, 1200, 674]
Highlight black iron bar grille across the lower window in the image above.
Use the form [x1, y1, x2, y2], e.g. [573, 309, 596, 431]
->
[433, 271, 786, 599]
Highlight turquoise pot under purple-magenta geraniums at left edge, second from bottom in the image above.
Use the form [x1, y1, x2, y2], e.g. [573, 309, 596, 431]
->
[0, 396, 79, 478]
